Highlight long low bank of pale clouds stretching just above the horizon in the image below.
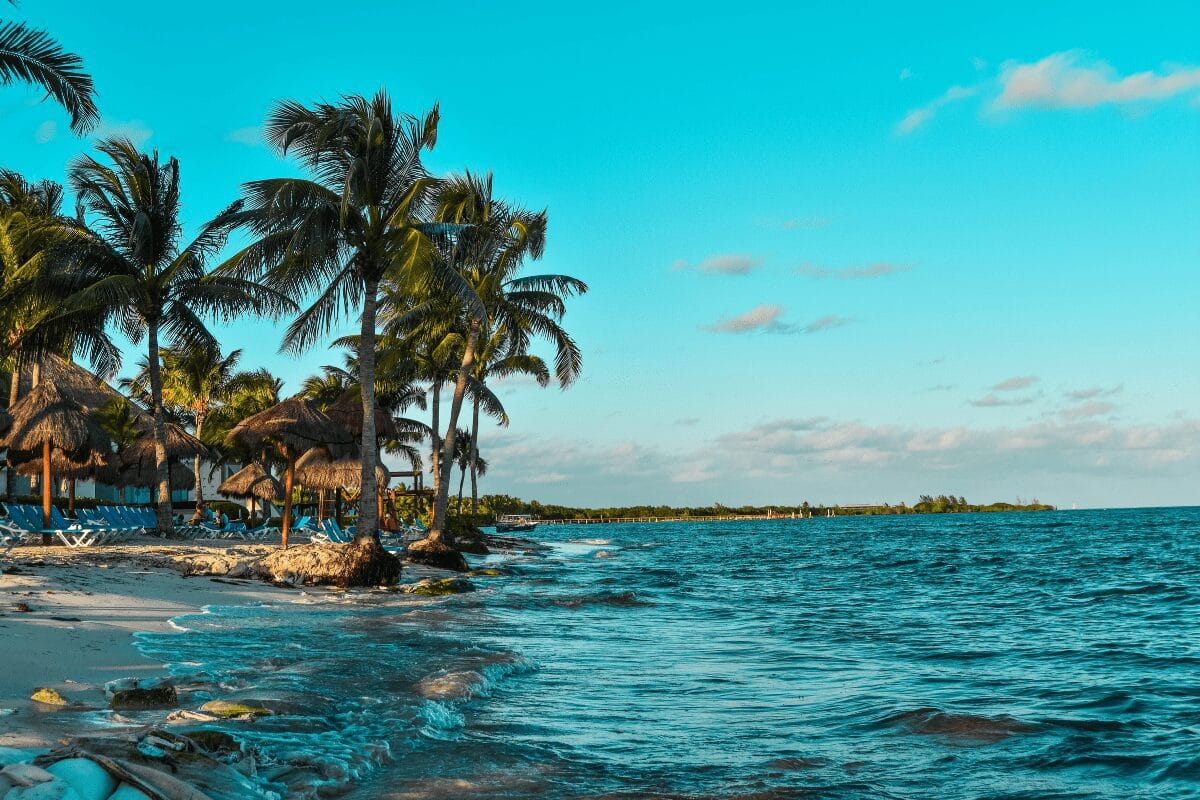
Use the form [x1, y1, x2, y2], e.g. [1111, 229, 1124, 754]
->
[481, 417, 1200, 506]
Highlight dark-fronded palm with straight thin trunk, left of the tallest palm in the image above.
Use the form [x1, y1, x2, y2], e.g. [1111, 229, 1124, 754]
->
[68, 138, 295, 533]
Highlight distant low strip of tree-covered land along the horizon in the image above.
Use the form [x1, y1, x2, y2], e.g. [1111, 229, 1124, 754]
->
[475, 494, 1056, 524]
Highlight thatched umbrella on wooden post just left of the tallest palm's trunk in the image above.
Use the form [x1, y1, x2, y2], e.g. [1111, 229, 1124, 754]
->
[226, 397, 353, 549]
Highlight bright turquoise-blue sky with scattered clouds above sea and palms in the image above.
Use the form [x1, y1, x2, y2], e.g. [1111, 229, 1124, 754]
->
[0, 0, 1200, 507]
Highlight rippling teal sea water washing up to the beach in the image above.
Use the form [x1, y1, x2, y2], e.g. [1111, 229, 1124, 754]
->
[140, 509, 1200, 800]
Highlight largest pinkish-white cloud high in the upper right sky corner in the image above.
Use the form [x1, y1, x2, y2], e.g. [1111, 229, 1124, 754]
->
[992, 50, 1200, 109]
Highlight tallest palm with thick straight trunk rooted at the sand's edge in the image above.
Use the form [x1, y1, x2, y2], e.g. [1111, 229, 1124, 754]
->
[223, 91, 446, 539]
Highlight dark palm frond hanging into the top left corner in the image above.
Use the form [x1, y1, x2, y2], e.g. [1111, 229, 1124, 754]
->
[0, 6, 100, 133]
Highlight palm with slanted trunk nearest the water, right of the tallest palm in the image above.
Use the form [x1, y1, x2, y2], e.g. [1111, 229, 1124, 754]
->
[407, 173, 588, 544]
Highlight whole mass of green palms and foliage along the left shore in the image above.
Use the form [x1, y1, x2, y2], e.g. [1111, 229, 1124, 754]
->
[0, 22, 587, 563]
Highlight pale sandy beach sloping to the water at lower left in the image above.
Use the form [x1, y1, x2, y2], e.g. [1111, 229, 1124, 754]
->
[0, 539, 364, 747]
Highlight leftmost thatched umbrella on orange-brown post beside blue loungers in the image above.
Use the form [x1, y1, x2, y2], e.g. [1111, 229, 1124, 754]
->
[0, 381, 112, 528]
